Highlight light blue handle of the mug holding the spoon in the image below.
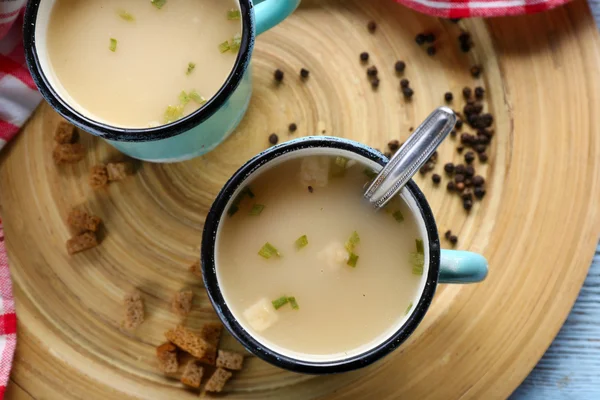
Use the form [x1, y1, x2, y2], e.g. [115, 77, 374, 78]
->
[439, 249, 488, 283]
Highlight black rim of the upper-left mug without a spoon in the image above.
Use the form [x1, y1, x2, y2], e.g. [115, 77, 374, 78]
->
[23, 0, 256, 142]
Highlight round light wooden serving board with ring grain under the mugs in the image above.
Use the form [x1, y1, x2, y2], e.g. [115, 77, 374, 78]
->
[0, 0, 600, 400]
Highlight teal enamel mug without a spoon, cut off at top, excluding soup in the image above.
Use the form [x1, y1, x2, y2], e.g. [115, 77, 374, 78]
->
[23, 0, 300, 163]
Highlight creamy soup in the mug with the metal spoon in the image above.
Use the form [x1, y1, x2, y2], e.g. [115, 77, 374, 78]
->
[216, 156, 427, 359]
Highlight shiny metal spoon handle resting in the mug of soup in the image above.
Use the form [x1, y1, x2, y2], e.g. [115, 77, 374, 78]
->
[364, 107, 456, 208]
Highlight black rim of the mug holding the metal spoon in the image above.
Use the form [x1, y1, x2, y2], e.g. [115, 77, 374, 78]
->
[201, 137, 440, 374]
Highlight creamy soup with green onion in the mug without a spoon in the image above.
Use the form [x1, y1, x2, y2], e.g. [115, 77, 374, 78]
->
[47, 0, 241, 128]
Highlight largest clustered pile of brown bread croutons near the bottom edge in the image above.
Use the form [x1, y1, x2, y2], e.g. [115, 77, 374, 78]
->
[156, 323, 244, 392]
